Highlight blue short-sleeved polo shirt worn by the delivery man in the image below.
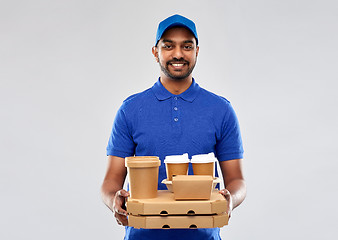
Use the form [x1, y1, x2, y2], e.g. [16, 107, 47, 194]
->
[107, 79, 243, 240]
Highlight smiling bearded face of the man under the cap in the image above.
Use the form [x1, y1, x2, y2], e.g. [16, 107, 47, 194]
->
[153, 27, 199, 81]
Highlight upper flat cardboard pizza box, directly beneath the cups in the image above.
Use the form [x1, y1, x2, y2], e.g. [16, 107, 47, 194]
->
[127, 190, 227, 216]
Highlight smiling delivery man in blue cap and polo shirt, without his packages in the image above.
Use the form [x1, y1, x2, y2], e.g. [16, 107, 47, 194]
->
[101, 15, 246, 240]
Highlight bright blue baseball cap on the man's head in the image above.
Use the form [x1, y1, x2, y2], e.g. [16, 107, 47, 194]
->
[155, 14, 198, 46]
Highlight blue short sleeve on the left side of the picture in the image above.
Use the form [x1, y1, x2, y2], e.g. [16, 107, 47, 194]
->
[107, 105, 135, 158]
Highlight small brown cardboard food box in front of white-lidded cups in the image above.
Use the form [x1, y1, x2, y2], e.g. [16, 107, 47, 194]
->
[173, 175, 214, 200]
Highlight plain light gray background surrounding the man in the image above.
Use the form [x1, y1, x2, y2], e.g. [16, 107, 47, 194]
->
[0, 0, 338, 240]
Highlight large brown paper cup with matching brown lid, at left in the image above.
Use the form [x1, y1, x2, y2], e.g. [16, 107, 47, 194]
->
[125, 156, 161, 199]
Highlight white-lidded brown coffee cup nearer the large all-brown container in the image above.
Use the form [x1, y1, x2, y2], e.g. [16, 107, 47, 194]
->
[164, 153, 190, 181]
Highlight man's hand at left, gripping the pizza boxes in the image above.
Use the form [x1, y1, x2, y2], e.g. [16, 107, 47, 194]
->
[112, 189, 130, 226]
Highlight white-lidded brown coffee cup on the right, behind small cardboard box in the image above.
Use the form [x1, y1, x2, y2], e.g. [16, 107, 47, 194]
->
[191, 152, 217, 177]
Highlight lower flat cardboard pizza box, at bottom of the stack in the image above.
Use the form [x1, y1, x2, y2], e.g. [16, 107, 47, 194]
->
[128, 213, 228, 229]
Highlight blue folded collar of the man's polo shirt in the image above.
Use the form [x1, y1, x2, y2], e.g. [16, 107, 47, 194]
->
[152, 78, 200, 102]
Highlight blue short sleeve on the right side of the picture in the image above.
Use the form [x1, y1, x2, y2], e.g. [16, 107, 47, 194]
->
[216, 103, 244, 161]
